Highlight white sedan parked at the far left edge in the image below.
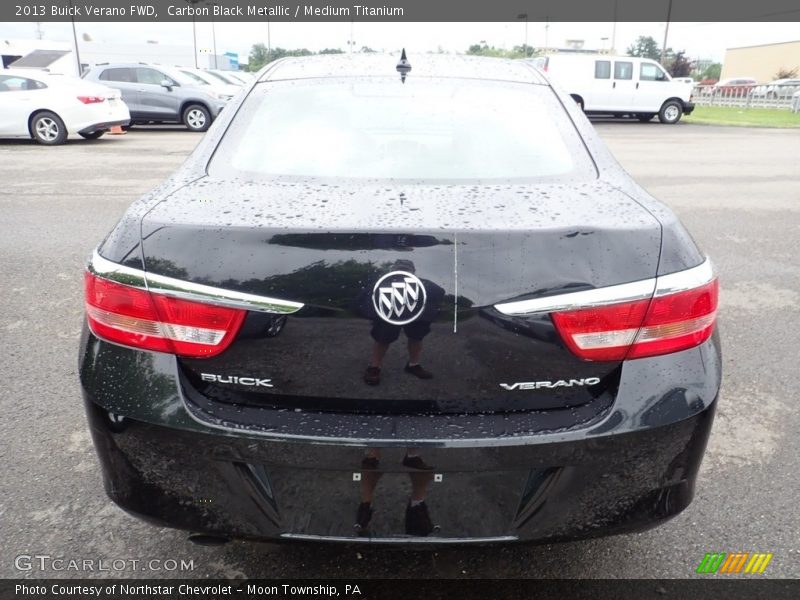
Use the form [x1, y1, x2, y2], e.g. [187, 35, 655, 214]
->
[0, 69, 131, 145]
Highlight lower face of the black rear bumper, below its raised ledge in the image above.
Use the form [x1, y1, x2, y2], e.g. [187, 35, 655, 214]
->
[87, 392, 715, 543]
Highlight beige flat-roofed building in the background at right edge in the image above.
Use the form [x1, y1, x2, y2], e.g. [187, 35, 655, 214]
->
[721, 40, 800, 83]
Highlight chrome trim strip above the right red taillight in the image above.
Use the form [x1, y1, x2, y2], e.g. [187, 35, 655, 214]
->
[494, 258, 714, 316]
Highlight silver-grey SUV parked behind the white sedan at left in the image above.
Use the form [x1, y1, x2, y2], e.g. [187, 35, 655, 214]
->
[83, 63, 231, 131]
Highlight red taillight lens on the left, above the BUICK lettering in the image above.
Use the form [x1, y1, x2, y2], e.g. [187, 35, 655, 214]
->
[85, 272, 247, 358]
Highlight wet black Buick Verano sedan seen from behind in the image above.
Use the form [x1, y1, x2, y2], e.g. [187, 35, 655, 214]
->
[80, 55, 721, 544]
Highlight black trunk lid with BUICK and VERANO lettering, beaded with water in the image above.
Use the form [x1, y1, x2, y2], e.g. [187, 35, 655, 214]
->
[142, 178, 661, 413]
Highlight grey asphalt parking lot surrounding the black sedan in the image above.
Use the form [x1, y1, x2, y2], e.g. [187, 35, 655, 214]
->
[0, 120, 800, 577]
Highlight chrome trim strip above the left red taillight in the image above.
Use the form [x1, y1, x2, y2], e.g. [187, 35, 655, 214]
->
[86, 250, 303, 315]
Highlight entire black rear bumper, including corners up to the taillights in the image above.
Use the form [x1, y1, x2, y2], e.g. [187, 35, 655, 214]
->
[81, 334, 720, 544]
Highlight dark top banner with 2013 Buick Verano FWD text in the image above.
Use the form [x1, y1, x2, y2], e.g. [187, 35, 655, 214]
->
[0, 0, 800, 22]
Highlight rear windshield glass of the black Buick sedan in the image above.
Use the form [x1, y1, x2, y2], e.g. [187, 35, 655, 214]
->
[209, 76, 596, 181]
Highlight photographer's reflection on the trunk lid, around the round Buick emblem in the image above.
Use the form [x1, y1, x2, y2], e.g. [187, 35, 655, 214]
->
[360, 259, 444, 385]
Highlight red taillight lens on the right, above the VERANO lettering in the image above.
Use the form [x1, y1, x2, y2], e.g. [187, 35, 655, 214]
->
[551, 279, 719, 360]
